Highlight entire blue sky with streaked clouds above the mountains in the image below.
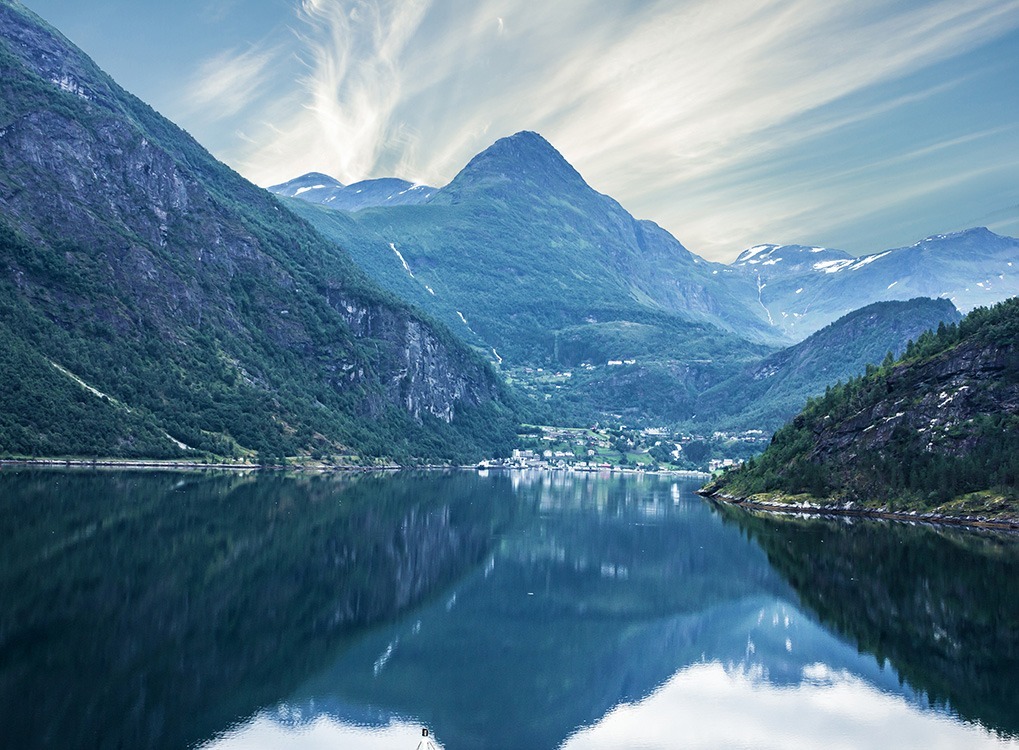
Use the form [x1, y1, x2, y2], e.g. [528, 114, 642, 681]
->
[24, 0, 1019, 261]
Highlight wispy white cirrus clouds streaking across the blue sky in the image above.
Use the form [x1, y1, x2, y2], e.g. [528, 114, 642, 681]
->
[179, 0, 1019, 259]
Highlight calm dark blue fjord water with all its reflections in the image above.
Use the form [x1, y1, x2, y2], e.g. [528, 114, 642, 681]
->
[0, 469, 1019, 750]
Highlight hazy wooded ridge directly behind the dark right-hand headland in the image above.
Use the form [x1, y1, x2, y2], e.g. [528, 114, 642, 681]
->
[697, 298, 962, 431]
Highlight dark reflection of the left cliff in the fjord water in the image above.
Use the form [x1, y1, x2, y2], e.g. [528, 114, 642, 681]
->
[0, 470, 515, 748]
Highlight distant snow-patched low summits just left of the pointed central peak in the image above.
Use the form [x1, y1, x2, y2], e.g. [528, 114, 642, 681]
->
[268, 172, 438, 211]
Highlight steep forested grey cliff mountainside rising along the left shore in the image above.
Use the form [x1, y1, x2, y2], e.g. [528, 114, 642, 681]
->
[0, 0, 513, 459]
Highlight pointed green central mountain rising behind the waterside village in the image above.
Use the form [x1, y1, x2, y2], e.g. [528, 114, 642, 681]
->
[281, 132, 774, 423]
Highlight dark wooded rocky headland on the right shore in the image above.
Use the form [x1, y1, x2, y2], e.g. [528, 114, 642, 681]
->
[711, 298, 1019, 518]
